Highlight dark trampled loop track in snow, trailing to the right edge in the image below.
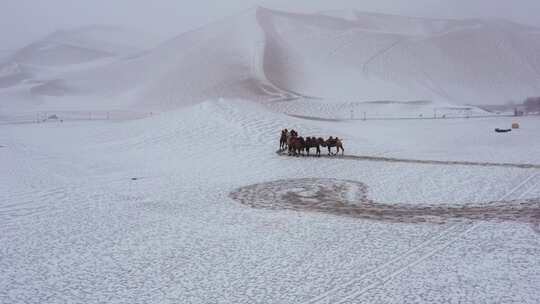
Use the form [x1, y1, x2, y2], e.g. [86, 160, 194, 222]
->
[230, 178, 540, 227]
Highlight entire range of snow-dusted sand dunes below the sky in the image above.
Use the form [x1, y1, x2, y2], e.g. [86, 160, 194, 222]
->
[0, 8, 540, 113]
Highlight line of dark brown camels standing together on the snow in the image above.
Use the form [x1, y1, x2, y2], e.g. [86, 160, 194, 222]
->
[279, 129, 345, 157]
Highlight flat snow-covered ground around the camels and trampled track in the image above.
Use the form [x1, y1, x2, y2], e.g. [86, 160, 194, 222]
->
[0, 99, 540, 303]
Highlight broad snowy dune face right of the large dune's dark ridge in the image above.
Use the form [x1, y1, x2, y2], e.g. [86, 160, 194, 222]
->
[259, 10, 540, 104]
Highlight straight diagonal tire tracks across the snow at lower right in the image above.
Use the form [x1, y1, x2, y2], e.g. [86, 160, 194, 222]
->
[304, 172, 540, 304]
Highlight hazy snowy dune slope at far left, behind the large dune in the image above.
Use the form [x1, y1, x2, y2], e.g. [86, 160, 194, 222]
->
[0, 26, 158, 101]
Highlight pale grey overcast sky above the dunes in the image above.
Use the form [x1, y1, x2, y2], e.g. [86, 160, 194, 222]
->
[0, 0, 540, 50]
